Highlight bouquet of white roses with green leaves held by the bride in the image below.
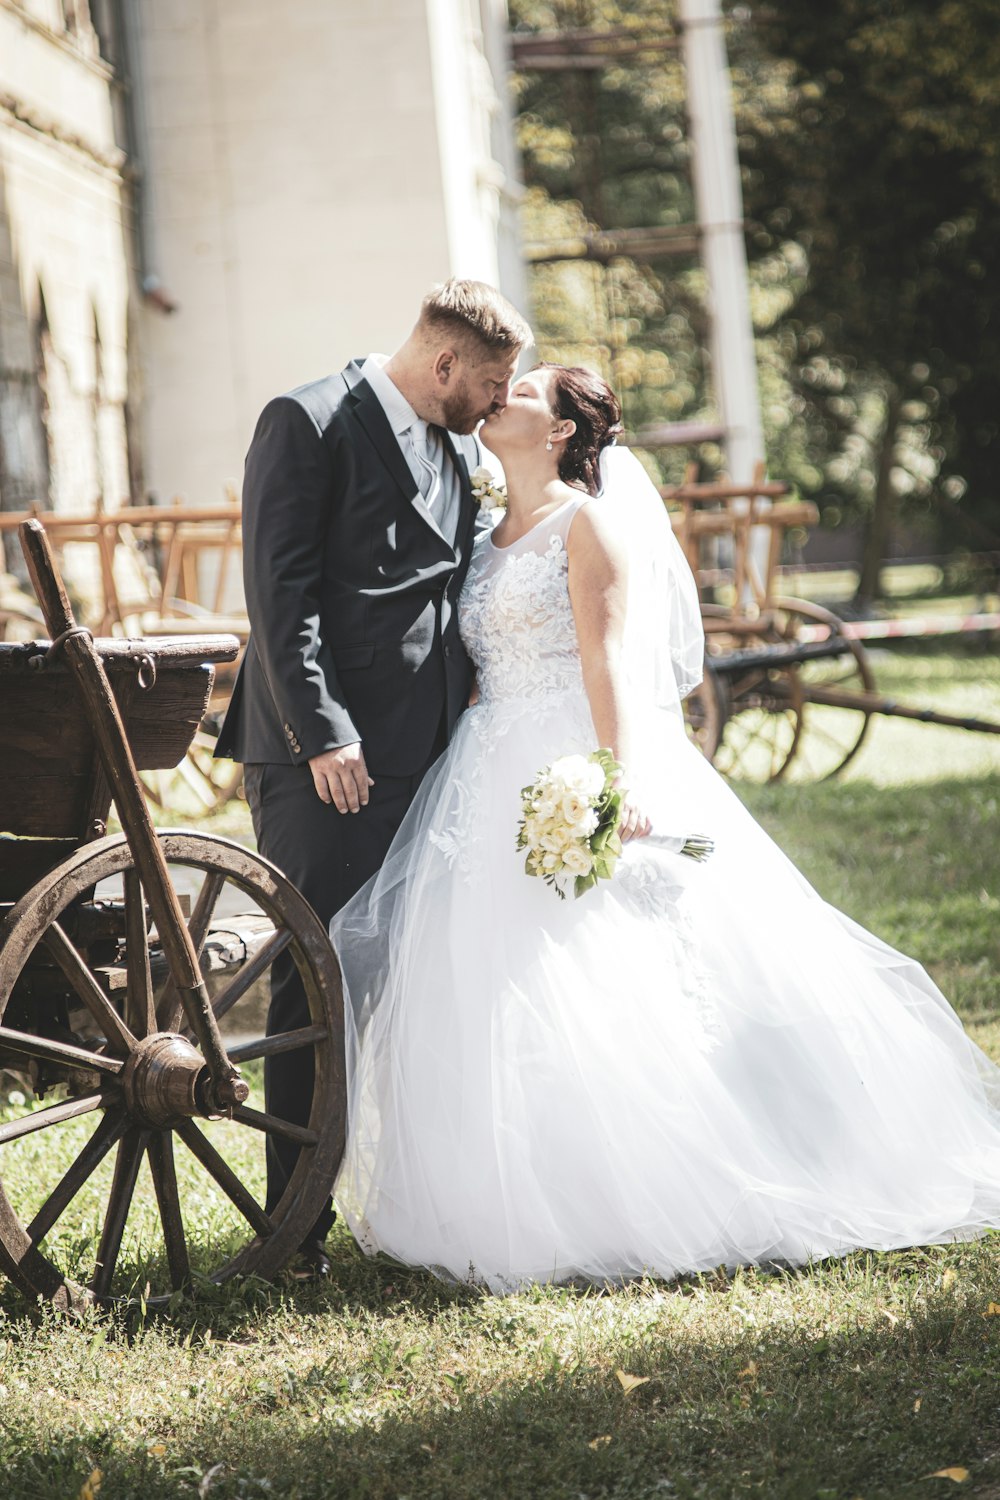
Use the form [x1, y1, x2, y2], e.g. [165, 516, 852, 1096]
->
[517, 750, 715, 900]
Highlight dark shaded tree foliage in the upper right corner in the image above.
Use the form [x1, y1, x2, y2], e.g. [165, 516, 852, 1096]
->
[738, 0, 1000, 558]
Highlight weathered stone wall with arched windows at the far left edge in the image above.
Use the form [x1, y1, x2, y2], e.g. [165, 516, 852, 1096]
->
[0, 0, 138, 543]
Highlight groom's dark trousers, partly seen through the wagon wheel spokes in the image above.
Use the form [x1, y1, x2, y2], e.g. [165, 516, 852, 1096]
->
[244, 725, 447, 1239]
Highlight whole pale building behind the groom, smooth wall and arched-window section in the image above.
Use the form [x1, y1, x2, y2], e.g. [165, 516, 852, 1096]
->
[0, 0, 525, 558]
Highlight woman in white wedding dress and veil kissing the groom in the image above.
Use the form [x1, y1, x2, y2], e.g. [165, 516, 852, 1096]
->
[331, 366, 1000, 1292]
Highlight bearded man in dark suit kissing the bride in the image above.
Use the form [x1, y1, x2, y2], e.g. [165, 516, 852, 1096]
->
[216, 281, 531, 1275]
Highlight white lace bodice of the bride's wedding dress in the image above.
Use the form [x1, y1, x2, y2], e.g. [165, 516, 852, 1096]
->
[459, 495, 588, 705]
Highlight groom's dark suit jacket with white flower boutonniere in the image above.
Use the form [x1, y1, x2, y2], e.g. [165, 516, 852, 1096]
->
[216, 362, 478, 776]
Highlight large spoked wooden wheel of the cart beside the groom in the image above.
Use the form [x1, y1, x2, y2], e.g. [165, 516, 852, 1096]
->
[0, 833, 345, 1307]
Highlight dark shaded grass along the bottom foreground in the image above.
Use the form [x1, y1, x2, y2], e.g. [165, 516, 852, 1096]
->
[0, 1257, 1000, 1500]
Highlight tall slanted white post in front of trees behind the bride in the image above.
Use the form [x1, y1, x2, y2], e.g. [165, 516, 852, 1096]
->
[678, 0, 765, 483]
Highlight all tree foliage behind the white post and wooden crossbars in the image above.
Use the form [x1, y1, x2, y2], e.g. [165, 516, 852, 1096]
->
[511, 0, 1000, 564]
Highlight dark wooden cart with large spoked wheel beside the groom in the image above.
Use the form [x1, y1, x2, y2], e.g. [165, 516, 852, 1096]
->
[0, 522, 345, 1307]
